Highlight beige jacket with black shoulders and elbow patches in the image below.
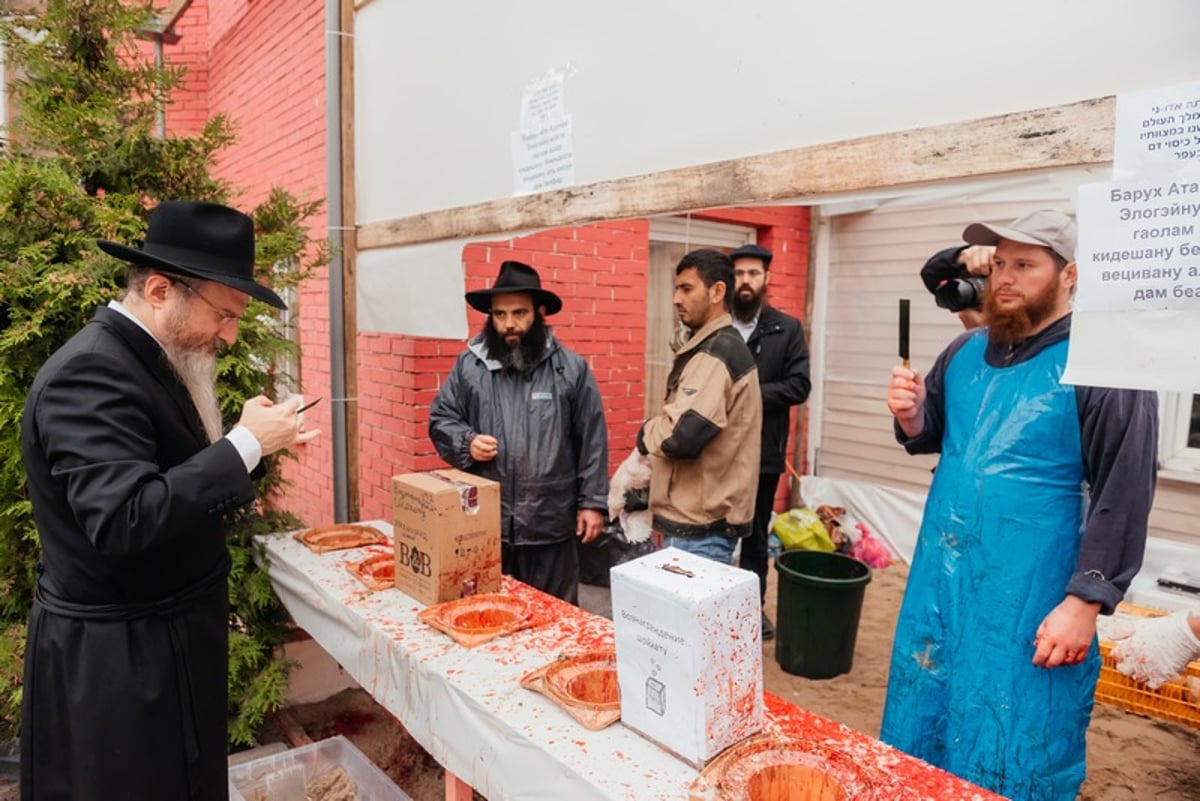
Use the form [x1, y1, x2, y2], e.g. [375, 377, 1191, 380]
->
[637, 314, 762, 537]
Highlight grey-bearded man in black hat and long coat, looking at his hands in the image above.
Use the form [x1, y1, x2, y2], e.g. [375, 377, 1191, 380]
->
[20, 200, 317, 801]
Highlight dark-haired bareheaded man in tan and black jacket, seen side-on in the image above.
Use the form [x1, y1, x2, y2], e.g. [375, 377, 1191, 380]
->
[637, 251, 762, 564]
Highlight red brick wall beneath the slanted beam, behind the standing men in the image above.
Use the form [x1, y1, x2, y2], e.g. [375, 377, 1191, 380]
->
[359, 206, 809, 519]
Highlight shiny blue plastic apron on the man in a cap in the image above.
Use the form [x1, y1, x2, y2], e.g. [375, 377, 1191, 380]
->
[880, 331, 1099, 801]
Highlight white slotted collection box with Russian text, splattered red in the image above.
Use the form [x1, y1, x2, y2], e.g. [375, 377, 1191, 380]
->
[610, 548, 763, 769]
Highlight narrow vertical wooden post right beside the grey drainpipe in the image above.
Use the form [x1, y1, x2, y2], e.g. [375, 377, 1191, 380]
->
[338, 0, 360, 522]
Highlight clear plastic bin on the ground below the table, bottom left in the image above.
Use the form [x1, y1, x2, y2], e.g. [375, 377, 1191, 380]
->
[229, 735, 412, 801]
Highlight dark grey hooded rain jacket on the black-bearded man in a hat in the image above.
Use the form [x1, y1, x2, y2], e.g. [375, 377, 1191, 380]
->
[430, 330, 608, 546]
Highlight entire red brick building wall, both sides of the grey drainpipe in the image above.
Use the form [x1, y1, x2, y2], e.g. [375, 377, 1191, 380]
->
[148, 0, 809, 525]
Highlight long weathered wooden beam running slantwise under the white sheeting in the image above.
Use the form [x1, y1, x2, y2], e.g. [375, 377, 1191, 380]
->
[358, 97, 1116, 251]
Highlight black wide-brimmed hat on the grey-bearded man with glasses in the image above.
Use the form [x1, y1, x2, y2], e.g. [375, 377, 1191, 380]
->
[96, 200, 288, 308]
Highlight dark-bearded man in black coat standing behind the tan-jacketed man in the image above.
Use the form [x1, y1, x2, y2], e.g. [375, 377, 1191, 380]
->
[730, 245, 812, 639]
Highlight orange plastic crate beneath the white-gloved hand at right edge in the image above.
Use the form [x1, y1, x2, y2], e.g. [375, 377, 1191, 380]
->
[1096, 603, 1200, 728]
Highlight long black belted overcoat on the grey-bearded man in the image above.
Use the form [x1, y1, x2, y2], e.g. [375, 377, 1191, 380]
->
[20, 308, 254, 801]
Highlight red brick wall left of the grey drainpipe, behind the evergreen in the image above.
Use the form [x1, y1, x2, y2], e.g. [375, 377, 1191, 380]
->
[198, 0, 334, 525]
